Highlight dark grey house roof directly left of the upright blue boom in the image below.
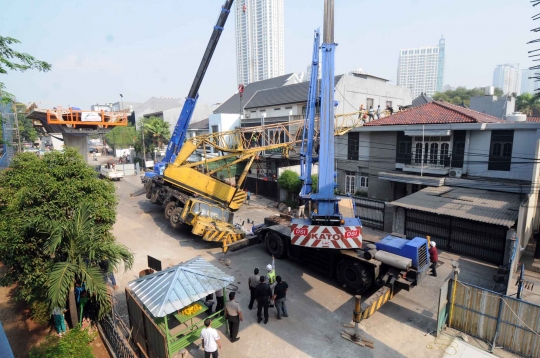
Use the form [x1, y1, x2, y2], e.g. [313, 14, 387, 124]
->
[244, 75, 343, 109]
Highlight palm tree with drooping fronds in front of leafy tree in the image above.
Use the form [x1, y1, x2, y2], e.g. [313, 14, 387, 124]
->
[37, 204, 133, 325]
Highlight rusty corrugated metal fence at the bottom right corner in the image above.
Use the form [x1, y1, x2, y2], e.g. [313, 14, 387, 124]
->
[438, 280, 540, 357]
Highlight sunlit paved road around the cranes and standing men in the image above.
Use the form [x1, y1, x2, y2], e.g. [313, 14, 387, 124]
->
[109, 177, 502, 358]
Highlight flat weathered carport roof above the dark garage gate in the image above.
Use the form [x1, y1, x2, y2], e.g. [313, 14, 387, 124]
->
[390, 186, 521, 227]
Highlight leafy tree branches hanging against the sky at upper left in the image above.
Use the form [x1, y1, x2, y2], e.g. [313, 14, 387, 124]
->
[0, 36, 51, 103]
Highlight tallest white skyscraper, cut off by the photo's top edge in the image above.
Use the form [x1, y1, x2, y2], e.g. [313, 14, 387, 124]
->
[236, 0, 285, 85]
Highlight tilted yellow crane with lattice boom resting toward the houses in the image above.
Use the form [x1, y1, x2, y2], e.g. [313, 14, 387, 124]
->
[145, 112, 363, 252]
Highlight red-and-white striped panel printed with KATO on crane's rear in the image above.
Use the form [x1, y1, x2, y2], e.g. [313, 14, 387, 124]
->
[291, 224, 362, 249]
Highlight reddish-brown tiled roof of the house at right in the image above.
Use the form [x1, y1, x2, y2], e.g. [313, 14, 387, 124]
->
[364, 101, 505, 126]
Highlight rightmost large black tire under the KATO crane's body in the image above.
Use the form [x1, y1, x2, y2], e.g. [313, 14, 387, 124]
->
[337, 259, 373, 295]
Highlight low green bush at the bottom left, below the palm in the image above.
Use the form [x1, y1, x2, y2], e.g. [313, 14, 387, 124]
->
[29, 327, 95, 358]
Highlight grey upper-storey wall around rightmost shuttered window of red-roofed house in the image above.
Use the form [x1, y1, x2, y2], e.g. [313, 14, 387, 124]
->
[465, 130, 540, 181]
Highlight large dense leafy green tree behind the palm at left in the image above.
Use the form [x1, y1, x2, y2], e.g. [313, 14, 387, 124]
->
[0, 148, 130, 310]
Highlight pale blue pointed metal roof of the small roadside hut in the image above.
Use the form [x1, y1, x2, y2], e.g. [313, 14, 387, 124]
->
[128, 257, 234, 317]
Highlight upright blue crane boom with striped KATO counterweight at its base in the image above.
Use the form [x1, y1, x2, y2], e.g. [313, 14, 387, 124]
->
[291, 1, 362, 238]
